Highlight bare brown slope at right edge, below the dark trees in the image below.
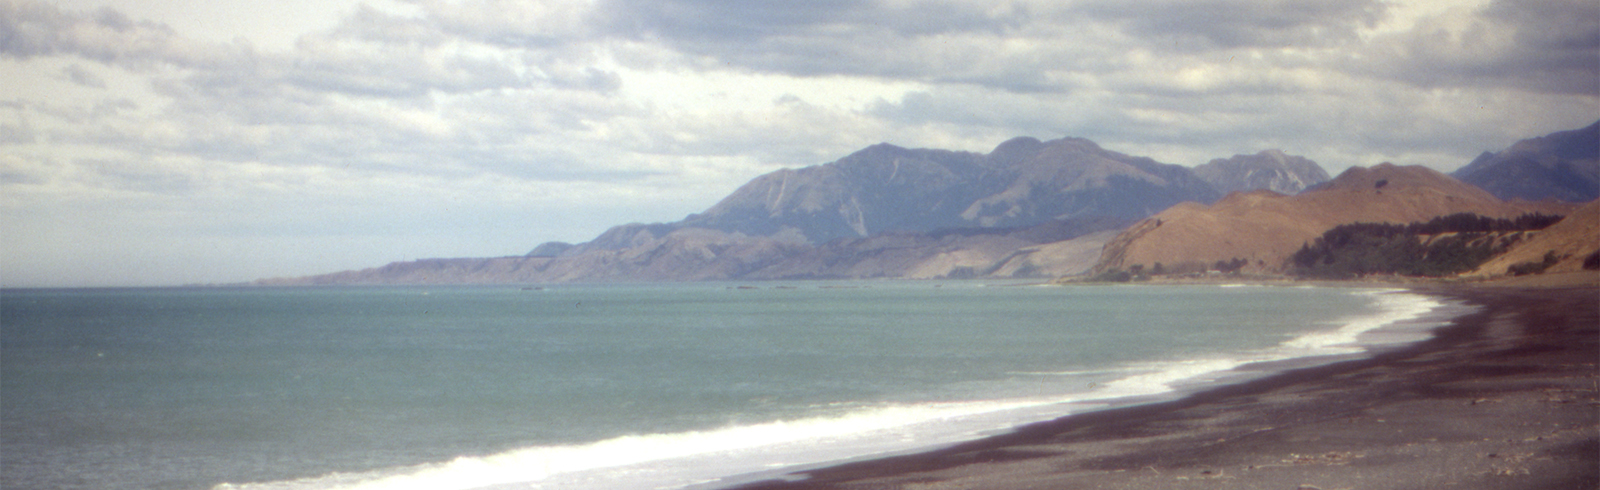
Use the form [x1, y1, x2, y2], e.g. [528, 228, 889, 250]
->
[1464, 200, 1600, 277]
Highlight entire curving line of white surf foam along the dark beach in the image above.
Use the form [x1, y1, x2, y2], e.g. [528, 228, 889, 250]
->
[216, 290, 1443, 490]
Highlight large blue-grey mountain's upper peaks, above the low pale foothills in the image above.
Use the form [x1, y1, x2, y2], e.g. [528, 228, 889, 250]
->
[677, 138, 1221, 243]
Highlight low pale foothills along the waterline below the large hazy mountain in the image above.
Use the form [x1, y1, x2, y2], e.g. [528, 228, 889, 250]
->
[256, 218, 1126, 285]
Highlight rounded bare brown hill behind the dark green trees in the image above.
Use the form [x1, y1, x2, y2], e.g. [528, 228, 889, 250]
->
[1094, 163, 1574, 274]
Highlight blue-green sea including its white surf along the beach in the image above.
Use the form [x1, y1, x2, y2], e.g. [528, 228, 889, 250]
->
[0, 282, 1461, 490]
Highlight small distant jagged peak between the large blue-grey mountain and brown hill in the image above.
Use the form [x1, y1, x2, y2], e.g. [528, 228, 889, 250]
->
[1195, 149, 1328, 194]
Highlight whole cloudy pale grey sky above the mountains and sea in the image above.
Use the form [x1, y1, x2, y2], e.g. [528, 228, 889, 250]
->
[0, 0, 1600, 287]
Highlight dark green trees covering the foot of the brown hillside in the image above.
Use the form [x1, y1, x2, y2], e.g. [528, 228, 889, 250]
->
[1290, 213, 1562, 279]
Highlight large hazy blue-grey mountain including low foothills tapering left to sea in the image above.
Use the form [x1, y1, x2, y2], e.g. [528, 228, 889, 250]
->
[261, 138, 1221, 283]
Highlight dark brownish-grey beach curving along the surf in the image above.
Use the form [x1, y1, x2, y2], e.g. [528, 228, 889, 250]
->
[738, 287, 1600, 490]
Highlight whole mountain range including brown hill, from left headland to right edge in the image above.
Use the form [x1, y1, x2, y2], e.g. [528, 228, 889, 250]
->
[256, 123, 1600, 285]
